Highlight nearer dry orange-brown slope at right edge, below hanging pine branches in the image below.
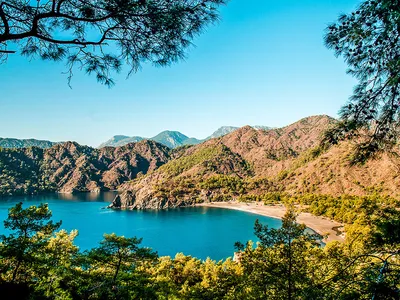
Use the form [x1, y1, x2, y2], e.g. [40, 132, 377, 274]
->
[281, 142, 400, 198]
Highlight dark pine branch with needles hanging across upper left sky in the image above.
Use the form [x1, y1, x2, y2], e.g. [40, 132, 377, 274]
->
[0, 0, 226, 86]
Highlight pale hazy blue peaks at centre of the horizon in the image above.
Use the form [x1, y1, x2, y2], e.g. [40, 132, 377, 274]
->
[98, 126, 272, 149]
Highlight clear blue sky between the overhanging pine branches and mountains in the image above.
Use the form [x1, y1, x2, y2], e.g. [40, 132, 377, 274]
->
[0, 0, 359, 146]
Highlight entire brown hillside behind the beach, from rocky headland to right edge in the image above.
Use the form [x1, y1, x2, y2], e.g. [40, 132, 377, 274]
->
[111, 116, 400, 208]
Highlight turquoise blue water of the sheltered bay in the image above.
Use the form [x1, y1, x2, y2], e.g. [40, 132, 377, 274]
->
[0, 193, 282, 260]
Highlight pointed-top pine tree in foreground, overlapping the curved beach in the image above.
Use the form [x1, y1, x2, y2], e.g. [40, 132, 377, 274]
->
[237, 208, 321, 300]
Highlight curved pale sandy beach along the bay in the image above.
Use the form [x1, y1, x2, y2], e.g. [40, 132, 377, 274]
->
[197, 202, 344, 242]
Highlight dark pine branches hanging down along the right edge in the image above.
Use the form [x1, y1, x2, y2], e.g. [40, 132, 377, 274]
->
[325, 0, 400, 162]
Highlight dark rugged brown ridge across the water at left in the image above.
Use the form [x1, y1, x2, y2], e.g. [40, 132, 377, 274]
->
[0, 141, 170, 195]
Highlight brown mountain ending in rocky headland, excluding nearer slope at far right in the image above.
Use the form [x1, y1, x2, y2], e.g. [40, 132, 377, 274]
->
[115, 116, 335, 209]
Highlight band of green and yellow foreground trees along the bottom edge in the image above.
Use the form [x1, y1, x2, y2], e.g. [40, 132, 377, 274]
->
[0, 203, 400, 299]
